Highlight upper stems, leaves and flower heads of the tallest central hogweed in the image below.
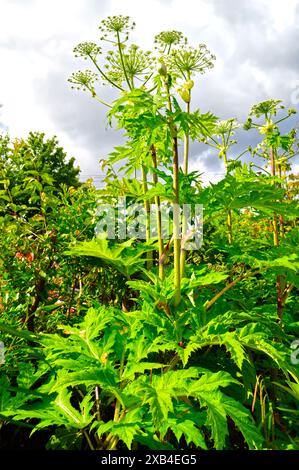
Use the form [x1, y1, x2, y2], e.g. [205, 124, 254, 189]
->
[70, 17, 215, 305]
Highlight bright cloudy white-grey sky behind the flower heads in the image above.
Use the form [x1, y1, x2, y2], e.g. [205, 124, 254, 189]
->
[0, 0, 299, 185]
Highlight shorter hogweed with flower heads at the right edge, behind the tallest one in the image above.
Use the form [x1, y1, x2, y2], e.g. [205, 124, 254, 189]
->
[201, 100, 298, 323]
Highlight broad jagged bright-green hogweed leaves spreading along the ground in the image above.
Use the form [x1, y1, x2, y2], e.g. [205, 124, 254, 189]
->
[0, 304, 298, 450]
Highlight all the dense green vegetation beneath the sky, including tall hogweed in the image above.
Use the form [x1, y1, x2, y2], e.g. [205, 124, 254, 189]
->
[0, 16, 299, 450]
